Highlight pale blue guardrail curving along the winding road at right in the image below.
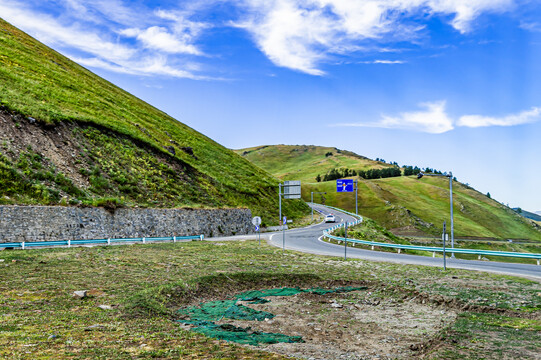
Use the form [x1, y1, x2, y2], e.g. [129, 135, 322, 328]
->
[323, 206, 541, 265]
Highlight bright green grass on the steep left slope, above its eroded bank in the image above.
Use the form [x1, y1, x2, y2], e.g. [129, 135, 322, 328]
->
[0, 19, 304, 222]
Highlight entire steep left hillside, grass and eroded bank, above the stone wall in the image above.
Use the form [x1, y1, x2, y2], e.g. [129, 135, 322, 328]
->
[0, 19, 307, 223]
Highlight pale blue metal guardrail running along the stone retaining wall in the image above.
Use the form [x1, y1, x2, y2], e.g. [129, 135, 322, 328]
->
[0, 235, 205, 250]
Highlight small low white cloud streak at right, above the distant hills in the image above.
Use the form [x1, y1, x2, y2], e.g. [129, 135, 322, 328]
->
[333, 101, 541, 134]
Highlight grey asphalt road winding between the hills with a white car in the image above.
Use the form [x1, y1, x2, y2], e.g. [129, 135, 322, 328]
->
[266, 206, 541, 281]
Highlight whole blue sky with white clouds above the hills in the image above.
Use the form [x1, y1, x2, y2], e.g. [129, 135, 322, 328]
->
[0, 0, 541, 211]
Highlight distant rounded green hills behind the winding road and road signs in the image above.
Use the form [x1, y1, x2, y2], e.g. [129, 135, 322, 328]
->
[237, 145, 541, 240]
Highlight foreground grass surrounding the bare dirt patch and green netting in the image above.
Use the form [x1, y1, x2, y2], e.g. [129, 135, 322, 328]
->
[0, 241, 541, 359]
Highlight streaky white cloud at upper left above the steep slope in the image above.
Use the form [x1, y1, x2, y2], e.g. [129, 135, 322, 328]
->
[0, 0, 208, 79]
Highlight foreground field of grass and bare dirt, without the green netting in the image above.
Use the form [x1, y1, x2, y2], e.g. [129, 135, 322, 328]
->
[0, 241, 541, 360]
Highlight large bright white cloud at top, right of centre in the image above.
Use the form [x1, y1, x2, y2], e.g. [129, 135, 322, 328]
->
[236, 0, 514, 75]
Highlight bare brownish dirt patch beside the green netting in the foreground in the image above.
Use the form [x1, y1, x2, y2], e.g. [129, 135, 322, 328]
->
[213, 290, 457, 360]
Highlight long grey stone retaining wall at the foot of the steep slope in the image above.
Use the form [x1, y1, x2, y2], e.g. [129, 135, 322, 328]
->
[0, 206, 252, 242]
